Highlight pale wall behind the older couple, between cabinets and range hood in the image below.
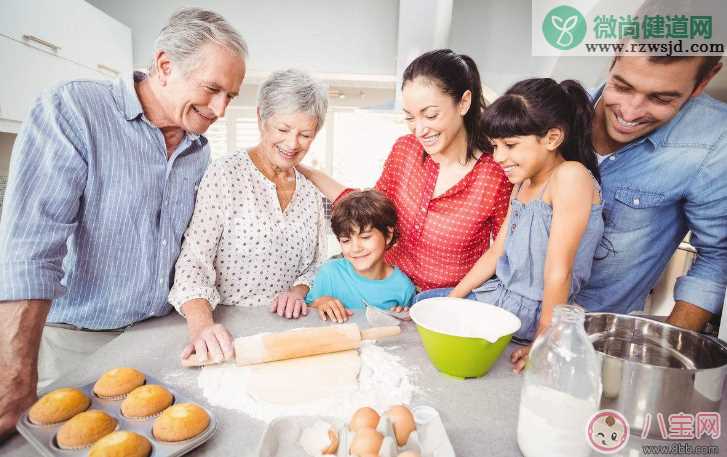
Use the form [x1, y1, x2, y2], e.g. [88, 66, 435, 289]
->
[89, 0, 399, 75]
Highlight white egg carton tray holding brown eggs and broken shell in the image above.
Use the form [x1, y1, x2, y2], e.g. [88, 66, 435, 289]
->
[258, 406, 455, 457]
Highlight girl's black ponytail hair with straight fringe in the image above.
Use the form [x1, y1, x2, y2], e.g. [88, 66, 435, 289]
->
[483, 78, 601, 183]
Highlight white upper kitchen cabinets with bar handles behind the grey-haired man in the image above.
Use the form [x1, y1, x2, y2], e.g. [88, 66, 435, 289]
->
[0, 0, 133, 132]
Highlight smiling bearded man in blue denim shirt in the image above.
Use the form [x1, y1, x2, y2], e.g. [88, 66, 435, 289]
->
[576, 56, 727, 330]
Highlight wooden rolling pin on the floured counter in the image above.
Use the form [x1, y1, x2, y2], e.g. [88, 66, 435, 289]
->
[182, 324, 401, 367]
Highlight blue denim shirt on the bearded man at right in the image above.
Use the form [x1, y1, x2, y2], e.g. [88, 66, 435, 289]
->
[576, 86, 727, 313]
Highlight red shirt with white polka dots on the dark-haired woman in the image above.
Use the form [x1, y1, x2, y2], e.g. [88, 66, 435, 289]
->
[339, 135, 512, 290]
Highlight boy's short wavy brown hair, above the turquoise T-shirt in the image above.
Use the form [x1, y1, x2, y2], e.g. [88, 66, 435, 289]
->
[331, 189, 399, 249]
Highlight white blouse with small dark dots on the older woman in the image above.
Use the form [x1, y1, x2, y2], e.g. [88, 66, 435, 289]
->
[169, 151, 326, 312]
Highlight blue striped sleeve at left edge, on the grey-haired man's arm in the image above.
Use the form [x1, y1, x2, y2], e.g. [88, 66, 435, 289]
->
[0, 87, 88, 300]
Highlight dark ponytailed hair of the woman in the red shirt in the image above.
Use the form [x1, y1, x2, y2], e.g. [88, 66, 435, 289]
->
[401, 49, 492, 161]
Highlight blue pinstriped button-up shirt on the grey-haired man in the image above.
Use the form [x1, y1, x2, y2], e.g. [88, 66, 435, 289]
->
[0, 73, 210, 329]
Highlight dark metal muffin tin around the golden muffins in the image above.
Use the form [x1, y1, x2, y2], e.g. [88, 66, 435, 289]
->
[17, 374, 217, 457]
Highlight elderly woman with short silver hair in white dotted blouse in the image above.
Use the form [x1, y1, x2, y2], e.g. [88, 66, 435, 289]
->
[169, 70, 328, 362]
